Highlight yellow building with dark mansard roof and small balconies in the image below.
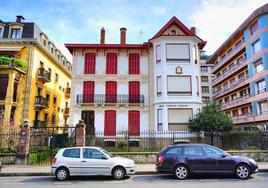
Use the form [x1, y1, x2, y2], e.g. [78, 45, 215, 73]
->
[0, 16, 72, 127]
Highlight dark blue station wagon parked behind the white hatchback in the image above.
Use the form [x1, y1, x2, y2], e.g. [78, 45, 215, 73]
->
[156, 144, 258, 180]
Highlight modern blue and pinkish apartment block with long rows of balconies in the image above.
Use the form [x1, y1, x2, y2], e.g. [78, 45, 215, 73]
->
[208, 4, 268, 130]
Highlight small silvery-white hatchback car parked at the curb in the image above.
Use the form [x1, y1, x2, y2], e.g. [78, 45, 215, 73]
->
[51, 147, 135, 181]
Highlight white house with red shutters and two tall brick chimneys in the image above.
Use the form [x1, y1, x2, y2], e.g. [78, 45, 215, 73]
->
[66, 17, 206, 135]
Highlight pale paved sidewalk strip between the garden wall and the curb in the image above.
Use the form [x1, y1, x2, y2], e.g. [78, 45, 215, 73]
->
[0, 162, 268, 176]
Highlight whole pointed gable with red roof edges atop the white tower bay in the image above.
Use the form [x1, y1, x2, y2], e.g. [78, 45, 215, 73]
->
[150, 16, 206, 49]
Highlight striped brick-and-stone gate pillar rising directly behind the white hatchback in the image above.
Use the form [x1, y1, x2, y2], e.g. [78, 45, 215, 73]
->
[75, 119, 86, 147]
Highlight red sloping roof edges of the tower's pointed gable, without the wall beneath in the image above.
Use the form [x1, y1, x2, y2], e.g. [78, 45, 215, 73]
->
[150, 16, 206, 48]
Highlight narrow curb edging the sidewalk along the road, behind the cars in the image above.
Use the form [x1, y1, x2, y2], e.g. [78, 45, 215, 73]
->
[0, 169, 268, 177]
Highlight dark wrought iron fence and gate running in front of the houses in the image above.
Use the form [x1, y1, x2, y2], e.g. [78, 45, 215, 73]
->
[0, 127, 268, 156]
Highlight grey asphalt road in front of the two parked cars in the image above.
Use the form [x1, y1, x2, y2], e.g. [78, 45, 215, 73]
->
[0, 173, 268, 188]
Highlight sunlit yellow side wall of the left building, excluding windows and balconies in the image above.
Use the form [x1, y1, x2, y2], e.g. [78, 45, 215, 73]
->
[29, 47, 71, 126]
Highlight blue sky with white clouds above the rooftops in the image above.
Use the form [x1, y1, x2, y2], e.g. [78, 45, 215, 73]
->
[0, 0, 268, 60]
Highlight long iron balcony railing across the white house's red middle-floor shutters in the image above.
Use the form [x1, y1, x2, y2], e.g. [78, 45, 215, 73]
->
[76, 94, 144, 104]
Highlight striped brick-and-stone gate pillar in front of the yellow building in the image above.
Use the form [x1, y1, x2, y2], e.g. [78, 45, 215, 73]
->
[16, 119, 30, 165]
